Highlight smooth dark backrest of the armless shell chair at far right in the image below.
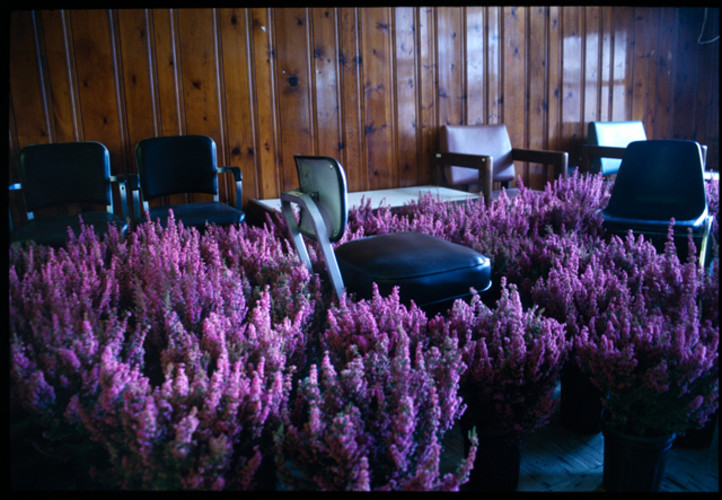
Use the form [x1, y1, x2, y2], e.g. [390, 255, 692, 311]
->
[604, 140, 707, 221]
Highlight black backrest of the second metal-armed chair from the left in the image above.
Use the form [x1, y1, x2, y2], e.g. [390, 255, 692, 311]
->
[135, 135, 218, 200]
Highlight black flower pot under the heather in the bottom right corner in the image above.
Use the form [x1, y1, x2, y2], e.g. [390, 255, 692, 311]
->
[603, 425, 675, 491]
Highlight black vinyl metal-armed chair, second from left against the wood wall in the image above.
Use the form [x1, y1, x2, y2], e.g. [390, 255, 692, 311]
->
[133, 135, 246, 229]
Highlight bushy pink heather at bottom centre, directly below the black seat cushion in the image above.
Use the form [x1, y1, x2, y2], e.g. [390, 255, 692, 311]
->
[276, 291, 476, 491]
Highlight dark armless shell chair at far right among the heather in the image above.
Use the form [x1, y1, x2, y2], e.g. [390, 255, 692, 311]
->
[601, 140, 713, 266]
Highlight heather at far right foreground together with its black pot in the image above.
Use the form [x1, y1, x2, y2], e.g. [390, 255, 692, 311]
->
[560, 236, 719, 491]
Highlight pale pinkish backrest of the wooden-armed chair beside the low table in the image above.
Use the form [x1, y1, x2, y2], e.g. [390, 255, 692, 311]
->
[439, 124, 515, 186]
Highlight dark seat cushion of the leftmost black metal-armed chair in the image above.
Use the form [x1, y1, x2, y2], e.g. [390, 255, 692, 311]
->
[10, 212, 128, 246]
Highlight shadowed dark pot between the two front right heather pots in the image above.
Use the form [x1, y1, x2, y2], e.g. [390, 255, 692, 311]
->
[559, 362, 602, 434]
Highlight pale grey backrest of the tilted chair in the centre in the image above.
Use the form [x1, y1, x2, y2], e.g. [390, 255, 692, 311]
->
[294, 155, 348, 243]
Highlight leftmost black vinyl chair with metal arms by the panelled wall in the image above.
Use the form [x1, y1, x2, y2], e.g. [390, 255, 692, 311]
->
[10, 141, 129, 247]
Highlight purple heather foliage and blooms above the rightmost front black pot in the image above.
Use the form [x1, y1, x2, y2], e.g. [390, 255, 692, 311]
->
[532, 233, 719, 435]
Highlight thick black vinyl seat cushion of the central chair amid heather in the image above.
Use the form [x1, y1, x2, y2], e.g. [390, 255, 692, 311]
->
[336, 233, 491, 307]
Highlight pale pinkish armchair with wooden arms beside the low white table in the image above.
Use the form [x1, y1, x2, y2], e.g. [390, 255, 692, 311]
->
[436, 124, 569, 200]
